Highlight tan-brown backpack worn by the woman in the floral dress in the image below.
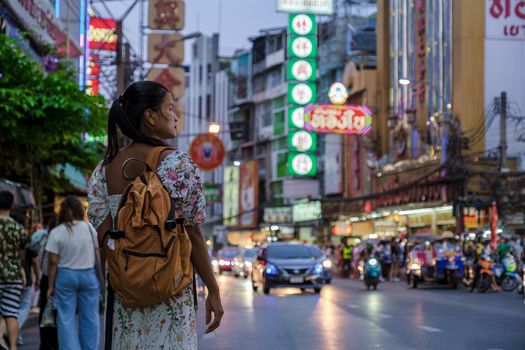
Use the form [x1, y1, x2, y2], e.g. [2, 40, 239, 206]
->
[103, 147, 193, 308]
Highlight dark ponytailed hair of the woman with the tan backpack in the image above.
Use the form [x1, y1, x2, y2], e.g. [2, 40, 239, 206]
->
[103, 80, 169, 165]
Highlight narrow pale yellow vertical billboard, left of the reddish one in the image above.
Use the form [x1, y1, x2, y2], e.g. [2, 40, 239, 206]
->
[222, 166, 240, 226]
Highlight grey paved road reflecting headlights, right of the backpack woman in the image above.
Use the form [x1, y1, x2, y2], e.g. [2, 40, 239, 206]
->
[21, 276, 525, 350]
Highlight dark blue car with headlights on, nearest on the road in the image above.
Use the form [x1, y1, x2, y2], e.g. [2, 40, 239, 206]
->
[252, 243, 325, 294]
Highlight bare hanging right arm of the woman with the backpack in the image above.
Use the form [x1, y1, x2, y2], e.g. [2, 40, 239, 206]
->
[186, 225, 224, 333]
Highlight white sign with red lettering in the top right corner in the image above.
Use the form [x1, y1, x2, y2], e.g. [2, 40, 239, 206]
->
[485, 0, 525, 40]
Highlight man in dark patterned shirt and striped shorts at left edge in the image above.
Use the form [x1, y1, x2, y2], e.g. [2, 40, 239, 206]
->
[0, 191, 27, 350]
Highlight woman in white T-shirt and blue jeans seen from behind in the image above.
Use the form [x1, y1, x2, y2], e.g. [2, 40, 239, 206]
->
[46, 195, 100, 350]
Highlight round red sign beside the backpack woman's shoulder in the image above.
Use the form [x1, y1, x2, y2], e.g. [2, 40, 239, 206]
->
[190, 134, 226, 171]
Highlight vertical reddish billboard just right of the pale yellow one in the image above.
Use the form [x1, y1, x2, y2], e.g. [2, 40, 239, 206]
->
[239, 160, 259, 228]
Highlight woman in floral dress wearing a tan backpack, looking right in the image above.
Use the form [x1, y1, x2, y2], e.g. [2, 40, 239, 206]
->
[88, 81, 223, 349]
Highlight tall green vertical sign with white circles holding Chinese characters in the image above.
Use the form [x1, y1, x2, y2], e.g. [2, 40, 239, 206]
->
[281, 12, 317, 176]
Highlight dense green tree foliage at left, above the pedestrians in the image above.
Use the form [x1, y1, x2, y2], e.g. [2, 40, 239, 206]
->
[0, 35, 107, 200]
